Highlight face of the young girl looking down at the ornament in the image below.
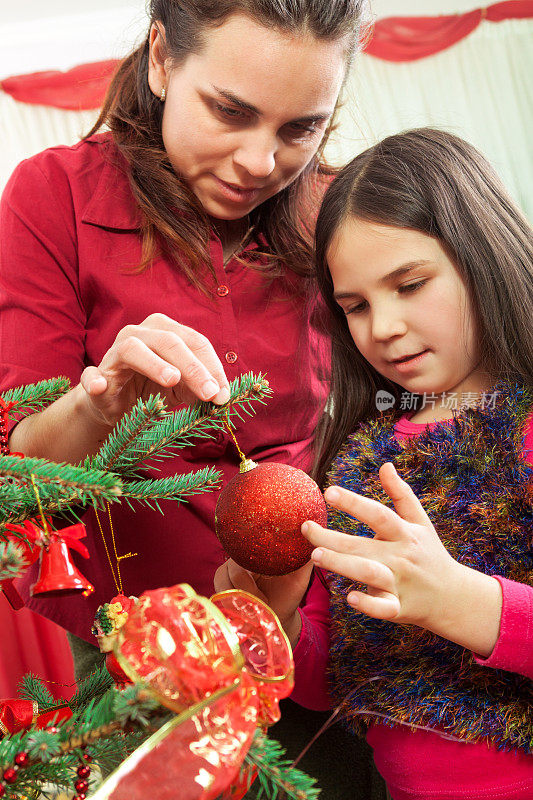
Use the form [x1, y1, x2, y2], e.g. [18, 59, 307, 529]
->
[328, 217, 487, 395]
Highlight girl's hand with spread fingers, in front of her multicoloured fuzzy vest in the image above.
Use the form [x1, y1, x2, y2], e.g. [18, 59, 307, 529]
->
[302, 463, 501, 654]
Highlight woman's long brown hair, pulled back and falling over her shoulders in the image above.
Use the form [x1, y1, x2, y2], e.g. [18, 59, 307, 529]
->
[86, 0, 366, 286]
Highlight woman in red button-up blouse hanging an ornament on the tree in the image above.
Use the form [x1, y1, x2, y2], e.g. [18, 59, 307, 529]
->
[0, 0, 382, 792]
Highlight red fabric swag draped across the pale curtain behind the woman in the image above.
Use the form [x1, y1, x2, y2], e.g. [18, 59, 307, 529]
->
[0, 0, 533, 111]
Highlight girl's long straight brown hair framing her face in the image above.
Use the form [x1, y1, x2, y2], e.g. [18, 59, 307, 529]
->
[314, 128, 533, 483]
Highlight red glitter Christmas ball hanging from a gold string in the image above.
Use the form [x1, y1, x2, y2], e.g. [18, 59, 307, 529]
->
[215, 460, 327, 575]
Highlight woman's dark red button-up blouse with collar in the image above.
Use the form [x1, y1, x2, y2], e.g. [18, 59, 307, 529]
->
[0, 134, 327, 642]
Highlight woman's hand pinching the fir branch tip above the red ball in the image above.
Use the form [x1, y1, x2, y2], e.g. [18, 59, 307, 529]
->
[80, 314, 230, 427]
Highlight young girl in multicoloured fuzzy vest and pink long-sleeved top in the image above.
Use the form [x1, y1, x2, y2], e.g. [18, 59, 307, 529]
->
[216, 129, 533, 800]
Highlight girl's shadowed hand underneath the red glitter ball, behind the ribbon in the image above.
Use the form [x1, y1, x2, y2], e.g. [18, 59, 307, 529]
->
[214, 558, 313, 647]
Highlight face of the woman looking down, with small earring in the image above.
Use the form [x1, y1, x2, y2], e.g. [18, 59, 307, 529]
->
[148, 14, 346, 220]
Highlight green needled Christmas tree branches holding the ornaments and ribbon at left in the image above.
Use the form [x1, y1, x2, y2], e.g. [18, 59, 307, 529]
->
[0, 374, 318, 800]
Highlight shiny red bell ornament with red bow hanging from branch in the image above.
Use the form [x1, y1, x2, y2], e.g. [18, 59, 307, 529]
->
[31, 523, 94, 597]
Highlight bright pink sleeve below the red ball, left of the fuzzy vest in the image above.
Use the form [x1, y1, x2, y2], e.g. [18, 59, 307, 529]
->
[291, 577, 331, 711]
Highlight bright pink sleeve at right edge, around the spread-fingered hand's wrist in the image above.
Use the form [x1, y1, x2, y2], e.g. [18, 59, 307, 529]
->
[474, 415, 533, 679]
